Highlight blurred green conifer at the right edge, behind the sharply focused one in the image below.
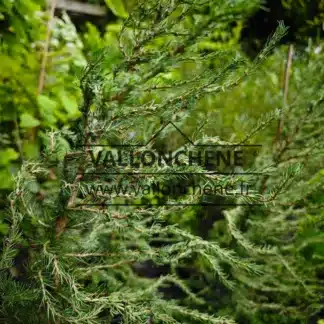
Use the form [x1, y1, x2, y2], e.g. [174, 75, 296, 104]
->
[231, 44, 324, 323]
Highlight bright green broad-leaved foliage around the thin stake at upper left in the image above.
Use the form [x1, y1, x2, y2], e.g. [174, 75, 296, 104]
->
[0, 0, 85, 189]
